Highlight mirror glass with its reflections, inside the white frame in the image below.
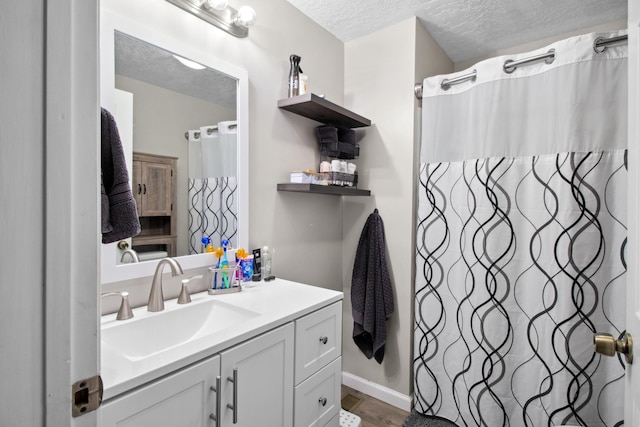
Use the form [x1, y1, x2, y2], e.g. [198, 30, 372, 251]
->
[114, 31, 238, 262]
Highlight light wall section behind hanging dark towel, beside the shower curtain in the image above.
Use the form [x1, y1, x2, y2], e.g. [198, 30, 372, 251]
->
[342, 18, 453, 396]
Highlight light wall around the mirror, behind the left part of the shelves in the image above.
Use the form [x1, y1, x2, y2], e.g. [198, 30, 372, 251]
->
[101, 0, 344, 290]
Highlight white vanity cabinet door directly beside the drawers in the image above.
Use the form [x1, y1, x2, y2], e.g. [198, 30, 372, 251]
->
[220, 323, 294, 427]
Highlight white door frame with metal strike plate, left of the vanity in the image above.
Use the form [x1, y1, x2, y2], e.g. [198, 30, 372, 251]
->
[45, 0, 100, 427]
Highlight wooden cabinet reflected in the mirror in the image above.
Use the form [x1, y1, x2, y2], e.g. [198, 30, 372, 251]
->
[132, 153, 177, 256]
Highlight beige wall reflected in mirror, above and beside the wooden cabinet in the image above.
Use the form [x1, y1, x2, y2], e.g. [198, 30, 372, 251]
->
[116, 75, 236, 256]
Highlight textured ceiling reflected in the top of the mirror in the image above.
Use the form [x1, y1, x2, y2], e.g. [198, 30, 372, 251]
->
[114, 32, 237, 110]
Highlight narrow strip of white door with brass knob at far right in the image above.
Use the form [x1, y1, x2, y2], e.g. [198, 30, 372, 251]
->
[620, 0, 640, 426]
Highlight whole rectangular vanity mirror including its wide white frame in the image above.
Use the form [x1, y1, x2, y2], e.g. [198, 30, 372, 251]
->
[100, 10, 248, 283]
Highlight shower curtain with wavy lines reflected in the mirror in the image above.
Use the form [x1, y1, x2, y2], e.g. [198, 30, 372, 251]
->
[189, 122, 238, 254]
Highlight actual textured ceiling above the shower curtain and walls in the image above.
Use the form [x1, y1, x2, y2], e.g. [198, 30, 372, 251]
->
[287, 0, 638, 62]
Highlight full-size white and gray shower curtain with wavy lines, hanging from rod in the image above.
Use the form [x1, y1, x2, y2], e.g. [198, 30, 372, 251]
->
[414, 30, 627, 427]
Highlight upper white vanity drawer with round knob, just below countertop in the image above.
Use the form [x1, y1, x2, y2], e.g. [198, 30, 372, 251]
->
[295, 301, 342, 384]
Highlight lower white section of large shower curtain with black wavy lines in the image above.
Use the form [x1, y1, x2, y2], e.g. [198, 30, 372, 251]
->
[413, 152, 627, 427]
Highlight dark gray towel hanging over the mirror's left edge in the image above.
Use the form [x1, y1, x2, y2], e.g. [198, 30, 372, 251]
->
[100, 108, 140, 243]
